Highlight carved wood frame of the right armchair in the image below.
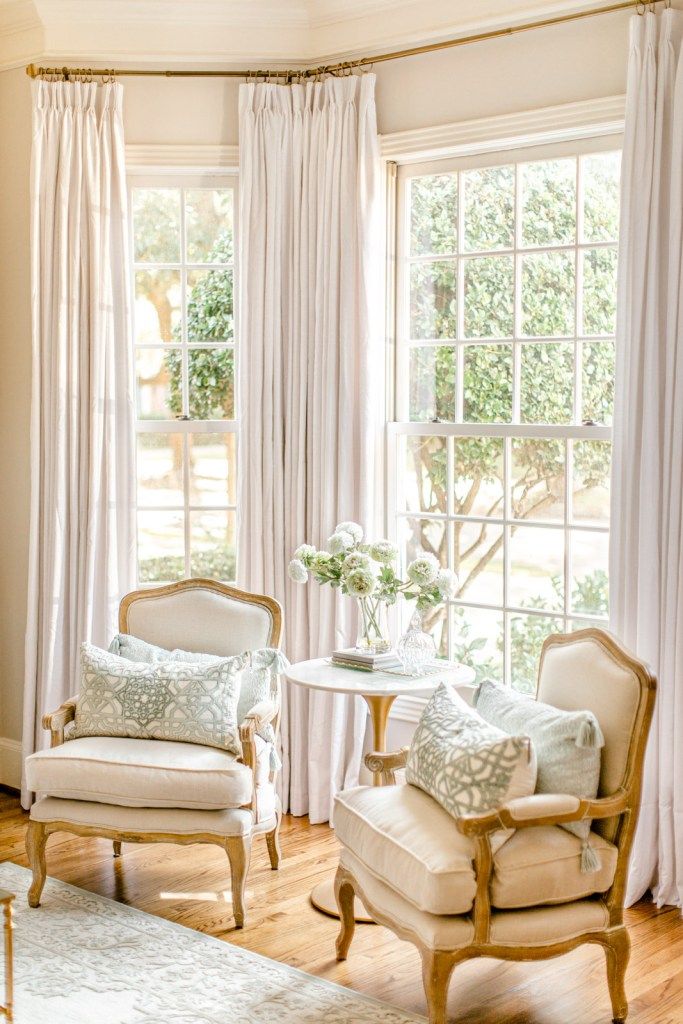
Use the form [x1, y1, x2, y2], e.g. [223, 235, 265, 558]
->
[335, 629, 656, 1024]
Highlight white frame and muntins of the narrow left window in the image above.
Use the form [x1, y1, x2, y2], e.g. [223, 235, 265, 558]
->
[127, 167, 240, 587]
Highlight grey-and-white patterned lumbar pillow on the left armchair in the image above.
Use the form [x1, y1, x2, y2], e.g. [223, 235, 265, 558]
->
[74, 643, 247, 754]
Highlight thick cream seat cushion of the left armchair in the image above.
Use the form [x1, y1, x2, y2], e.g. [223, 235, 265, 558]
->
[26, 736, 269, 810]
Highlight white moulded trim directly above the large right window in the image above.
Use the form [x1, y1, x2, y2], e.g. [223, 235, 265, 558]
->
[381, 96, 625, 163]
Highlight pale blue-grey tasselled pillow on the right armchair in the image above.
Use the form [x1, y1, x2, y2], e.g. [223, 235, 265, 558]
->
[476, 680, 604, 871]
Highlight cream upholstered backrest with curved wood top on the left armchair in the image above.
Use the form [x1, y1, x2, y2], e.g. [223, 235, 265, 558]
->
[119, 580, 281, 657]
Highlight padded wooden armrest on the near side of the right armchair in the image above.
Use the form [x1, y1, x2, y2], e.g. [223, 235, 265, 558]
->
[456, 791, 628, 836]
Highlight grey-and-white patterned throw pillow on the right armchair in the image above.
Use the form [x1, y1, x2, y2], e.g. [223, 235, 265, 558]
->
[405, 683, 536, 818]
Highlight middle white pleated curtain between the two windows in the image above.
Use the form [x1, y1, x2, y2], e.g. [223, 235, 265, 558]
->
[239, 75, 384, 821]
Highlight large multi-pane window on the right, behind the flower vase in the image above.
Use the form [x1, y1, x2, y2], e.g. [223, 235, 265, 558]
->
[389, 143, 620, 690]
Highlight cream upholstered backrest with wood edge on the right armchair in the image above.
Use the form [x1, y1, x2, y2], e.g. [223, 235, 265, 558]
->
[538, 629, 654, 839]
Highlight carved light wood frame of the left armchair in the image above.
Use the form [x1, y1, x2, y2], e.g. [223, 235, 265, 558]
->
[26, 579, 283, 928]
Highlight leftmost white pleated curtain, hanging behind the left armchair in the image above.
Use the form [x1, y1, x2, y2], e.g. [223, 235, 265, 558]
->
[24, 82, 134, 806]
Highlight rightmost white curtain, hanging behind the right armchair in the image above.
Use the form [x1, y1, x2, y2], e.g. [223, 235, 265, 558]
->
[610, 10, 683, 906]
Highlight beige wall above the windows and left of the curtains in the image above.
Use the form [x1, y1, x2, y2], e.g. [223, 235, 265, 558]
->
[0, 15, 628, 781]
